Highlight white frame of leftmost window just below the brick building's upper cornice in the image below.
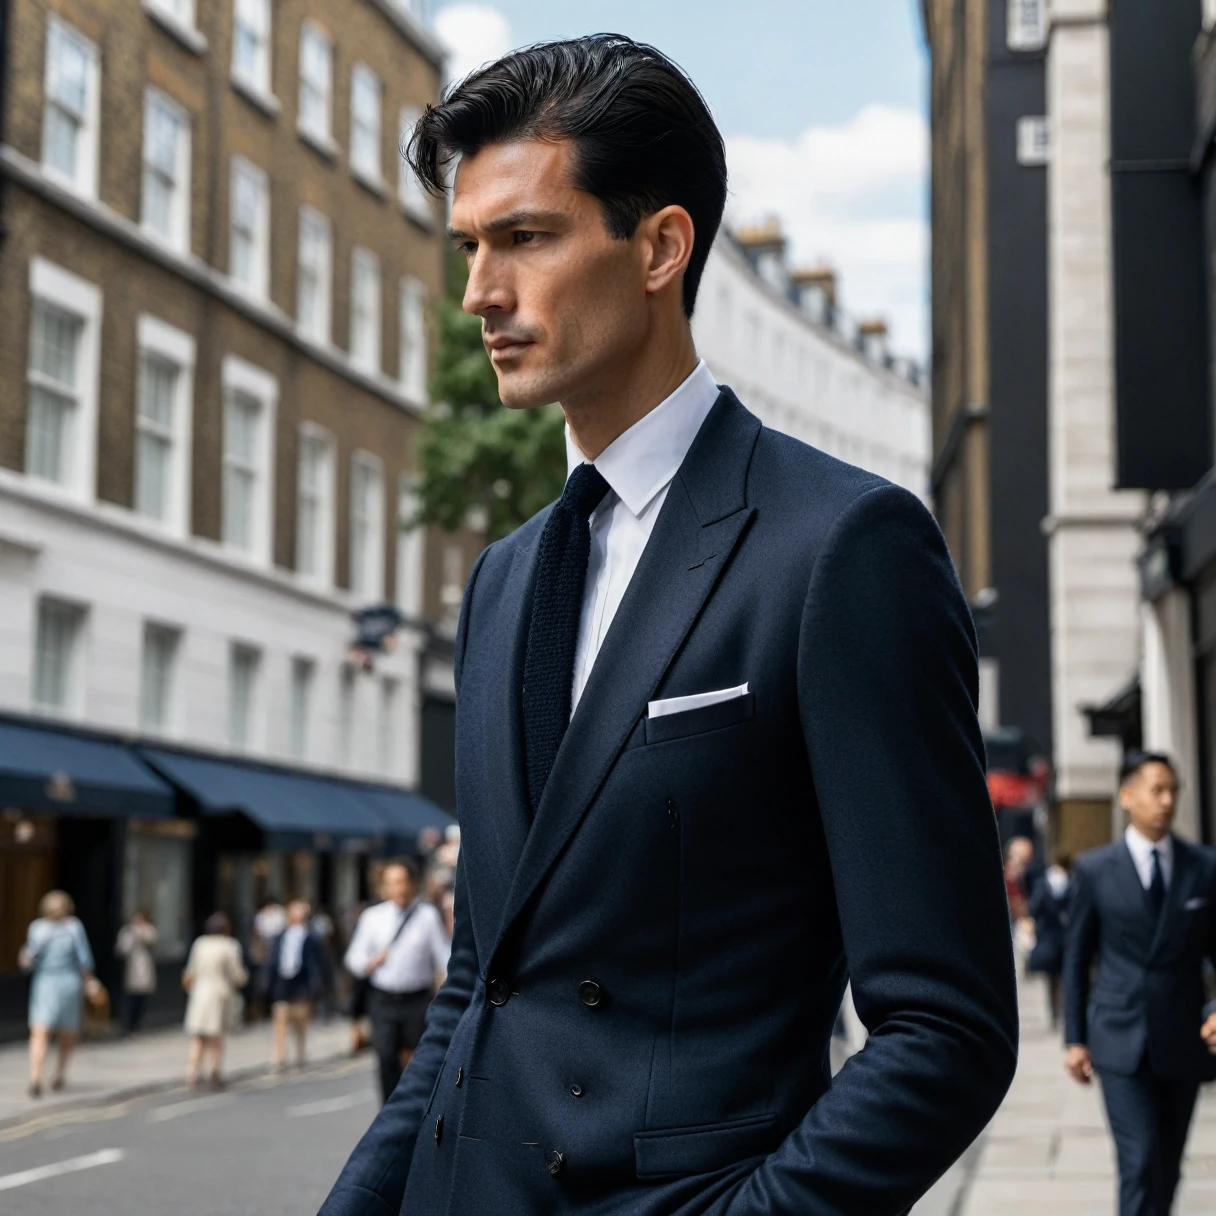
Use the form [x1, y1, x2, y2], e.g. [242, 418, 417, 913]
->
[26, 257, 102, 502]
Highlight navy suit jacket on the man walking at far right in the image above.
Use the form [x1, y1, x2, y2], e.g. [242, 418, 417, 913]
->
[1064, 837, 1216, 1081]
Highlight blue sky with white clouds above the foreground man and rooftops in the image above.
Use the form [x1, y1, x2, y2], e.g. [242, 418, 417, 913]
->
[434, 0, 928, 356]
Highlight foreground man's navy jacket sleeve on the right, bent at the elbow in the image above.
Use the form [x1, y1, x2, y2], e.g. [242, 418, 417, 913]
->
[726, 485, 1018, 1216]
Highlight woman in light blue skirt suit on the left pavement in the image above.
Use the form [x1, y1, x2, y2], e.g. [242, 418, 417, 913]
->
[21, 891, 94, 1098]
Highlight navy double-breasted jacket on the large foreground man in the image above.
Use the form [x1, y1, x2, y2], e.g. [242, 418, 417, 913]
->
[322, 389, 1017, 1216]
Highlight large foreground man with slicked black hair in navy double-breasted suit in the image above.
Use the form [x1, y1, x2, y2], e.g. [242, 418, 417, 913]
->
[322, 35, 1018, 1216]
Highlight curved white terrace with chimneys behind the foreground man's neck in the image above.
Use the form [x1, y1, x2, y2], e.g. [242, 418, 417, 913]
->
[693, 230, 930, 499]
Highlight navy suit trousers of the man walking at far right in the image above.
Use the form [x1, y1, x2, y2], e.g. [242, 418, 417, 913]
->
[1099, 1060, 1199, 1216]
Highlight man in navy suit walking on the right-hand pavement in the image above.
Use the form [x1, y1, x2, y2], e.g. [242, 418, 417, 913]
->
[1064, 753, 1216, 1216]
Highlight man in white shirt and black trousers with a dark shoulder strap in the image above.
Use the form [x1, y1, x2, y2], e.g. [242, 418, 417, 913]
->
[345, 861, 451, 1102]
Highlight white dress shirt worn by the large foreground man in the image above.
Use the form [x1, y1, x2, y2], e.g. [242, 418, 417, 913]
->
[565, 360, 719, 714]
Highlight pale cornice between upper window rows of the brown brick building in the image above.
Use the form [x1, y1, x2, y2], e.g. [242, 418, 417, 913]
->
[0, 143, 426, 417]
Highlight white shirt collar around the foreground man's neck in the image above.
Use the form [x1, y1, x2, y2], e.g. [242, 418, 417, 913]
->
[565, 360, 720, 516]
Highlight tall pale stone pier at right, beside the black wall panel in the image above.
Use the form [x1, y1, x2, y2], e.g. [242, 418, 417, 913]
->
[1043, 0, 1145, 817]
